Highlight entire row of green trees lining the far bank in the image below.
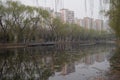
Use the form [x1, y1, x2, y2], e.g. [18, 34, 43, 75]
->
[0, 1, 111, 43]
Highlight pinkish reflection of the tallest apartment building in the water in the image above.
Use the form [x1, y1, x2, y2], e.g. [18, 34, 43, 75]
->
[61, 63, 75, 75]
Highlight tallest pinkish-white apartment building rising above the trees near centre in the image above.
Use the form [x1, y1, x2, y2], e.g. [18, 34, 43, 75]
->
[60, 9, 74, 23]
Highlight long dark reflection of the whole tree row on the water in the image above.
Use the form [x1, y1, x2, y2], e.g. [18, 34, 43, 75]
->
[0, 46, 113, 80]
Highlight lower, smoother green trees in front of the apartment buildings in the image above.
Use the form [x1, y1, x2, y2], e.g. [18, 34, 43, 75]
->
[48, 19, 109, 41]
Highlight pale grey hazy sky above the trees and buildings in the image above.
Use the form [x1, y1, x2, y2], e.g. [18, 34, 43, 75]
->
[16, 0, 107, 18]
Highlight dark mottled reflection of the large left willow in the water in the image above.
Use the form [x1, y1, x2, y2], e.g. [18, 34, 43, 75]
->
[0, 50, 53, 80]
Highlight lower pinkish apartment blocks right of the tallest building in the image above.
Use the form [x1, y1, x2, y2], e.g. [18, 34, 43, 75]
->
[75, 17, 109, 31]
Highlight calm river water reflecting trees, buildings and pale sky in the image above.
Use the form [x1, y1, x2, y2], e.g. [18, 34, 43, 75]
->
[0, 45, 119, 80]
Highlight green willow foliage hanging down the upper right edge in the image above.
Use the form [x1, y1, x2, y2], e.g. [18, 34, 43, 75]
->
[108, 0, 120, 39]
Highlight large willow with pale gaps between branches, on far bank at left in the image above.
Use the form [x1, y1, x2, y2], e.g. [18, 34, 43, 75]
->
[0, 1, 49, 43]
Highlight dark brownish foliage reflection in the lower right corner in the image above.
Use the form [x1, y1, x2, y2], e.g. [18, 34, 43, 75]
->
[109, 47, 120, 80]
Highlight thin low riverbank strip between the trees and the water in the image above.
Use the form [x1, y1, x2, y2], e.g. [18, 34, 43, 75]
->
[0, 41, 115, 49]
